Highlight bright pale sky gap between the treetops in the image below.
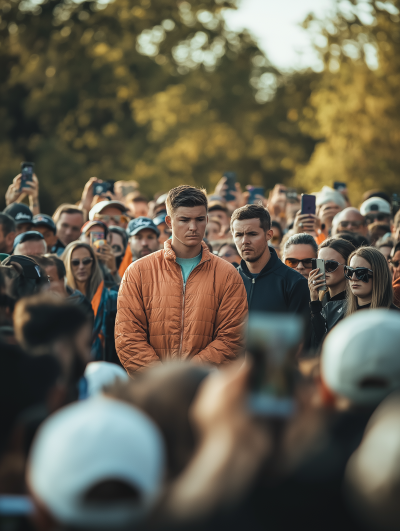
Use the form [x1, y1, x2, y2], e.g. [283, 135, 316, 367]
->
[224, 0, 335, 71]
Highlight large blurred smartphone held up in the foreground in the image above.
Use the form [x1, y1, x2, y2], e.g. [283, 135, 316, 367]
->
[246, 313, 303, 417]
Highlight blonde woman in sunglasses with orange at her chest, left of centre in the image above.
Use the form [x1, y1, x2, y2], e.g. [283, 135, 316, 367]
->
[61, 241, 119, 363]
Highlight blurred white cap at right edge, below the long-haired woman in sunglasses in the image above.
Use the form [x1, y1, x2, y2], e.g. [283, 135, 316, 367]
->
[321, 309, 400, 405]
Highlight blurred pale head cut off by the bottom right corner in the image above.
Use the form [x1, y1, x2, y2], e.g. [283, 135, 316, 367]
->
[345, 393, 400, 531]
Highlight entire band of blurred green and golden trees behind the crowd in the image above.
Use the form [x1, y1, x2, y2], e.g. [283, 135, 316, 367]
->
[0, 0, 400, 213]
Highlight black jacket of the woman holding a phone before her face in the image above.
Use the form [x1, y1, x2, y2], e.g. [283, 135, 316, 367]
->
[310, 291, 346, 352]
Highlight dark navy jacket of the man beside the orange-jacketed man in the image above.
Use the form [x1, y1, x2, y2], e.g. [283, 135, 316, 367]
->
[238, 247, 310, 316]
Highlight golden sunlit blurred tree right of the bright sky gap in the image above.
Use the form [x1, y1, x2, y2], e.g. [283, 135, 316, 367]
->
[293, 0, 400, 205]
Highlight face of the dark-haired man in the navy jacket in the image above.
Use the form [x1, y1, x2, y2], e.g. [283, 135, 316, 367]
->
[232, 218, 273, 262]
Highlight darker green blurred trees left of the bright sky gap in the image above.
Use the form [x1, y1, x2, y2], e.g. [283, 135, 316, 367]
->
[0, 0, 318, 213]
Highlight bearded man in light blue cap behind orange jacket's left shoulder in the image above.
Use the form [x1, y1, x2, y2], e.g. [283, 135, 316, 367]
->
[127, 217, 160, 262]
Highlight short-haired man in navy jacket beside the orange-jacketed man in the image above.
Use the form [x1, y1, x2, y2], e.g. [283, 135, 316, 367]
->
[231, 205, 310, 319]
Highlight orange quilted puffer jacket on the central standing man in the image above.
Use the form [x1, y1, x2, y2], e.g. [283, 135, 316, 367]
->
[115, 240, 247, 375]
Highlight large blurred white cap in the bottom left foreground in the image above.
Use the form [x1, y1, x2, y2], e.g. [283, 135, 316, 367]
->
[27, 395, 165, 529]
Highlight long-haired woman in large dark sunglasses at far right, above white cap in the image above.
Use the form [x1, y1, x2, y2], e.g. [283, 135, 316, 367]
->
[344, 247, 398, 317]
